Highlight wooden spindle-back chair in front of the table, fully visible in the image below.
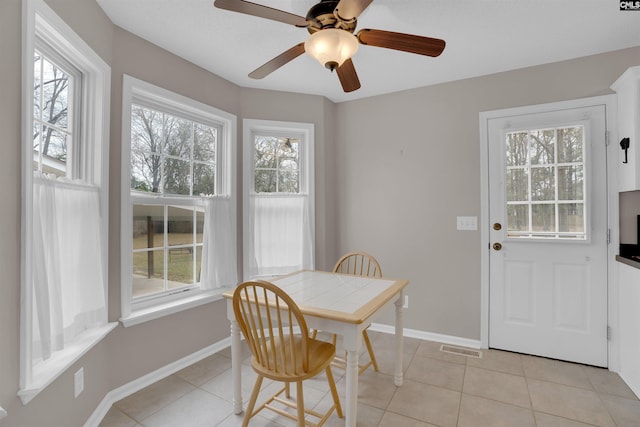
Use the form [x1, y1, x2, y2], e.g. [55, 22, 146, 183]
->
[233, 281, 343, 427]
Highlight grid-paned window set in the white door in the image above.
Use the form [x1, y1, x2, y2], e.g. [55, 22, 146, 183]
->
[505, 125, 587, 240]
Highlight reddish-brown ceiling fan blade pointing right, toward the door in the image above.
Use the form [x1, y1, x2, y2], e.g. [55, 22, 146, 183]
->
[357, 29, 446, 56]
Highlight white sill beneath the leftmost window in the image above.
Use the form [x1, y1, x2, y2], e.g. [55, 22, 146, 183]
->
[17, 322, 118, 404]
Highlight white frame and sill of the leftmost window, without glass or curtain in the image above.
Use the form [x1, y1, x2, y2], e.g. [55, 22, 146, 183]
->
[18, 0, 117, 404]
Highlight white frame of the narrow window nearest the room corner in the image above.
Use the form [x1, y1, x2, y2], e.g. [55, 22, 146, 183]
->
[242, 119, 315, 280]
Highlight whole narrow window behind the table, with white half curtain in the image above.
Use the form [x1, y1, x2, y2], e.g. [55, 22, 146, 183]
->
[244, 120, 314, 279]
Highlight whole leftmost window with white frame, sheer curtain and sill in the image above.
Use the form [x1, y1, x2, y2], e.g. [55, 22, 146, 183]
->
[18, 0, 115, 403]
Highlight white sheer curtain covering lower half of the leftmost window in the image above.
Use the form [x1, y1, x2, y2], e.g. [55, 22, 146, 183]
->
[32, 175, 107, 363]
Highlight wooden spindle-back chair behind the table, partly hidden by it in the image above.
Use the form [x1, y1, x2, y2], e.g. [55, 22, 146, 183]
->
[311, 252, 382, 374]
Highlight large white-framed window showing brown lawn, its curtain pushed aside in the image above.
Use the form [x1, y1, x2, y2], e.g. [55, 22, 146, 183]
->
[122, 76, 237, 325]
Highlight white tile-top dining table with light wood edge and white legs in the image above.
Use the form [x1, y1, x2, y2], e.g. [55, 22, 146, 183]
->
[223, 270, 409, 427]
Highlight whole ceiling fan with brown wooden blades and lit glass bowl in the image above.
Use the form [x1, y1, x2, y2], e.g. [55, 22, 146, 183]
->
[213, 0, 445, 92]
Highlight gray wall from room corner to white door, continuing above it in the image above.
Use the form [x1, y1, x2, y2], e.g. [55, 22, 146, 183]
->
[335, 48, 640, 340]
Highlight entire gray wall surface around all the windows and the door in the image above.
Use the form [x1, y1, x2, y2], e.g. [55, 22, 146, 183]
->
[0, 0, 640, 427]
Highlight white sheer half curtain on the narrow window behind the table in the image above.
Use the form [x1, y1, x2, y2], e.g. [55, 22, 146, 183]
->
[248, 194, 314, 277]
